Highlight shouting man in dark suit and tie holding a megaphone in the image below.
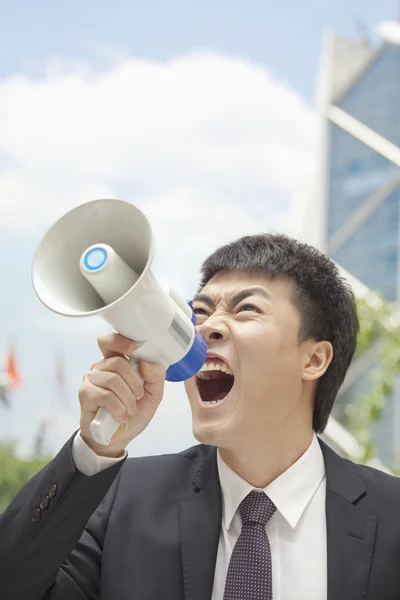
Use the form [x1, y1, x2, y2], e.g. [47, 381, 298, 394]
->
[0, 235, 400, 600]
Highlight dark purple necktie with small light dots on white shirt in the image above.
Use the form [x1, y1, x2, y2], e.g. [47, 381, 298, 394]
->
[224, 491, 276, 600]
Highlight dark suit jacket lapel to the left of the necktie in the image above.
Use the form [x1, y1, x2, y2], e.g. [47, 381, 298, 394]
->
[179, 449, 222, 600]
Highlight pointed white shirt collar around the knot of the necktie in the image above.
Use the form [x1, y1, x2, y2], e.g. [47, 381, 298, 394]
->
[217, 433, 325, 529]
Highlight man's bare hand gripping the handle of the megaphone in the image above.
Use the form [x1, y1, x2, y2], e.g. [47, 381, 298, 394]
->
[79, 333, 165, 457]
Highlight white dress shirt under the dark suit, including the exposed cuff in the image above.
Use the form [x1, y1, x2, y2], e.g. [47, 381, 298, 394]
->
[72, 432, 327, 600]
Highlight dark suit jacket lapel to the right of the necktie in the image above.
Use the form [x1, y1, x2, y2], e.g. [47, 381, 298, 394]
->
[319, 440, 377, 600]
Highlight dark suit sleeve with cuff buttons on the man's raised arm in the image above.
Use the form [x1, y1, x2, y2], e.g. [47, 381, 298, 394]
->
[0, 438, 124, 600]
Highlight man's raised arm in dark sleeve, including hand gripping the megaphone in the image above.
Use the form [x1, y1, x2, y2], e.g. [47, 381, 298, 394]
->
[0, 334, 165, 600]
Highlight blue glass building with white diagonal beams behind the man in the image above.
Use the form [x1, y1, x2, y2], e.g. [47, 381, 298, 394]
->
[319, 28, 400, 468]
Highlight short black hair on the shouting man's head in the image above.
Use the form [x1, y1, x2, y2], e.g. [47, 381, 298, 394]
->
[200, 233, 359, 433]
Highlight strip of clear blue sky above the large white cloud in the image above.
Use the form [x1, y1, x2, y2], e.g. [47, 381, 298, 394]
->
[0, 0, 397, 100]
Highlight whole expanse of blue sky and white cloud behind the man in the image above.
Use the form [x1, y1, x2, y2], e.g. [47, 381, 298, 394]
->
[0, 0, 397, 456]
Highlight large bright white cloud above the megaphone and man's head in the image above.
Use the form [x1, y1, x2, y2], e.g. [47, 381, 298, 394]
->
[0, 52, 316, 243]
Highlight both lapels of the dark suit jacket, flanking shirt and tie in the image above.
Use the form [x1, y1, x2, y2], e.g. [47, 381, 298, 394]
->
[179, 440, 377, 600]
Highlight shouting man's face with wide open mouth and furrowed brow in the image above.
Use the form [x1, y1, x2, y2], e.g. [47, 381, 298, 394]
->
[185, 271, 312, 448]
